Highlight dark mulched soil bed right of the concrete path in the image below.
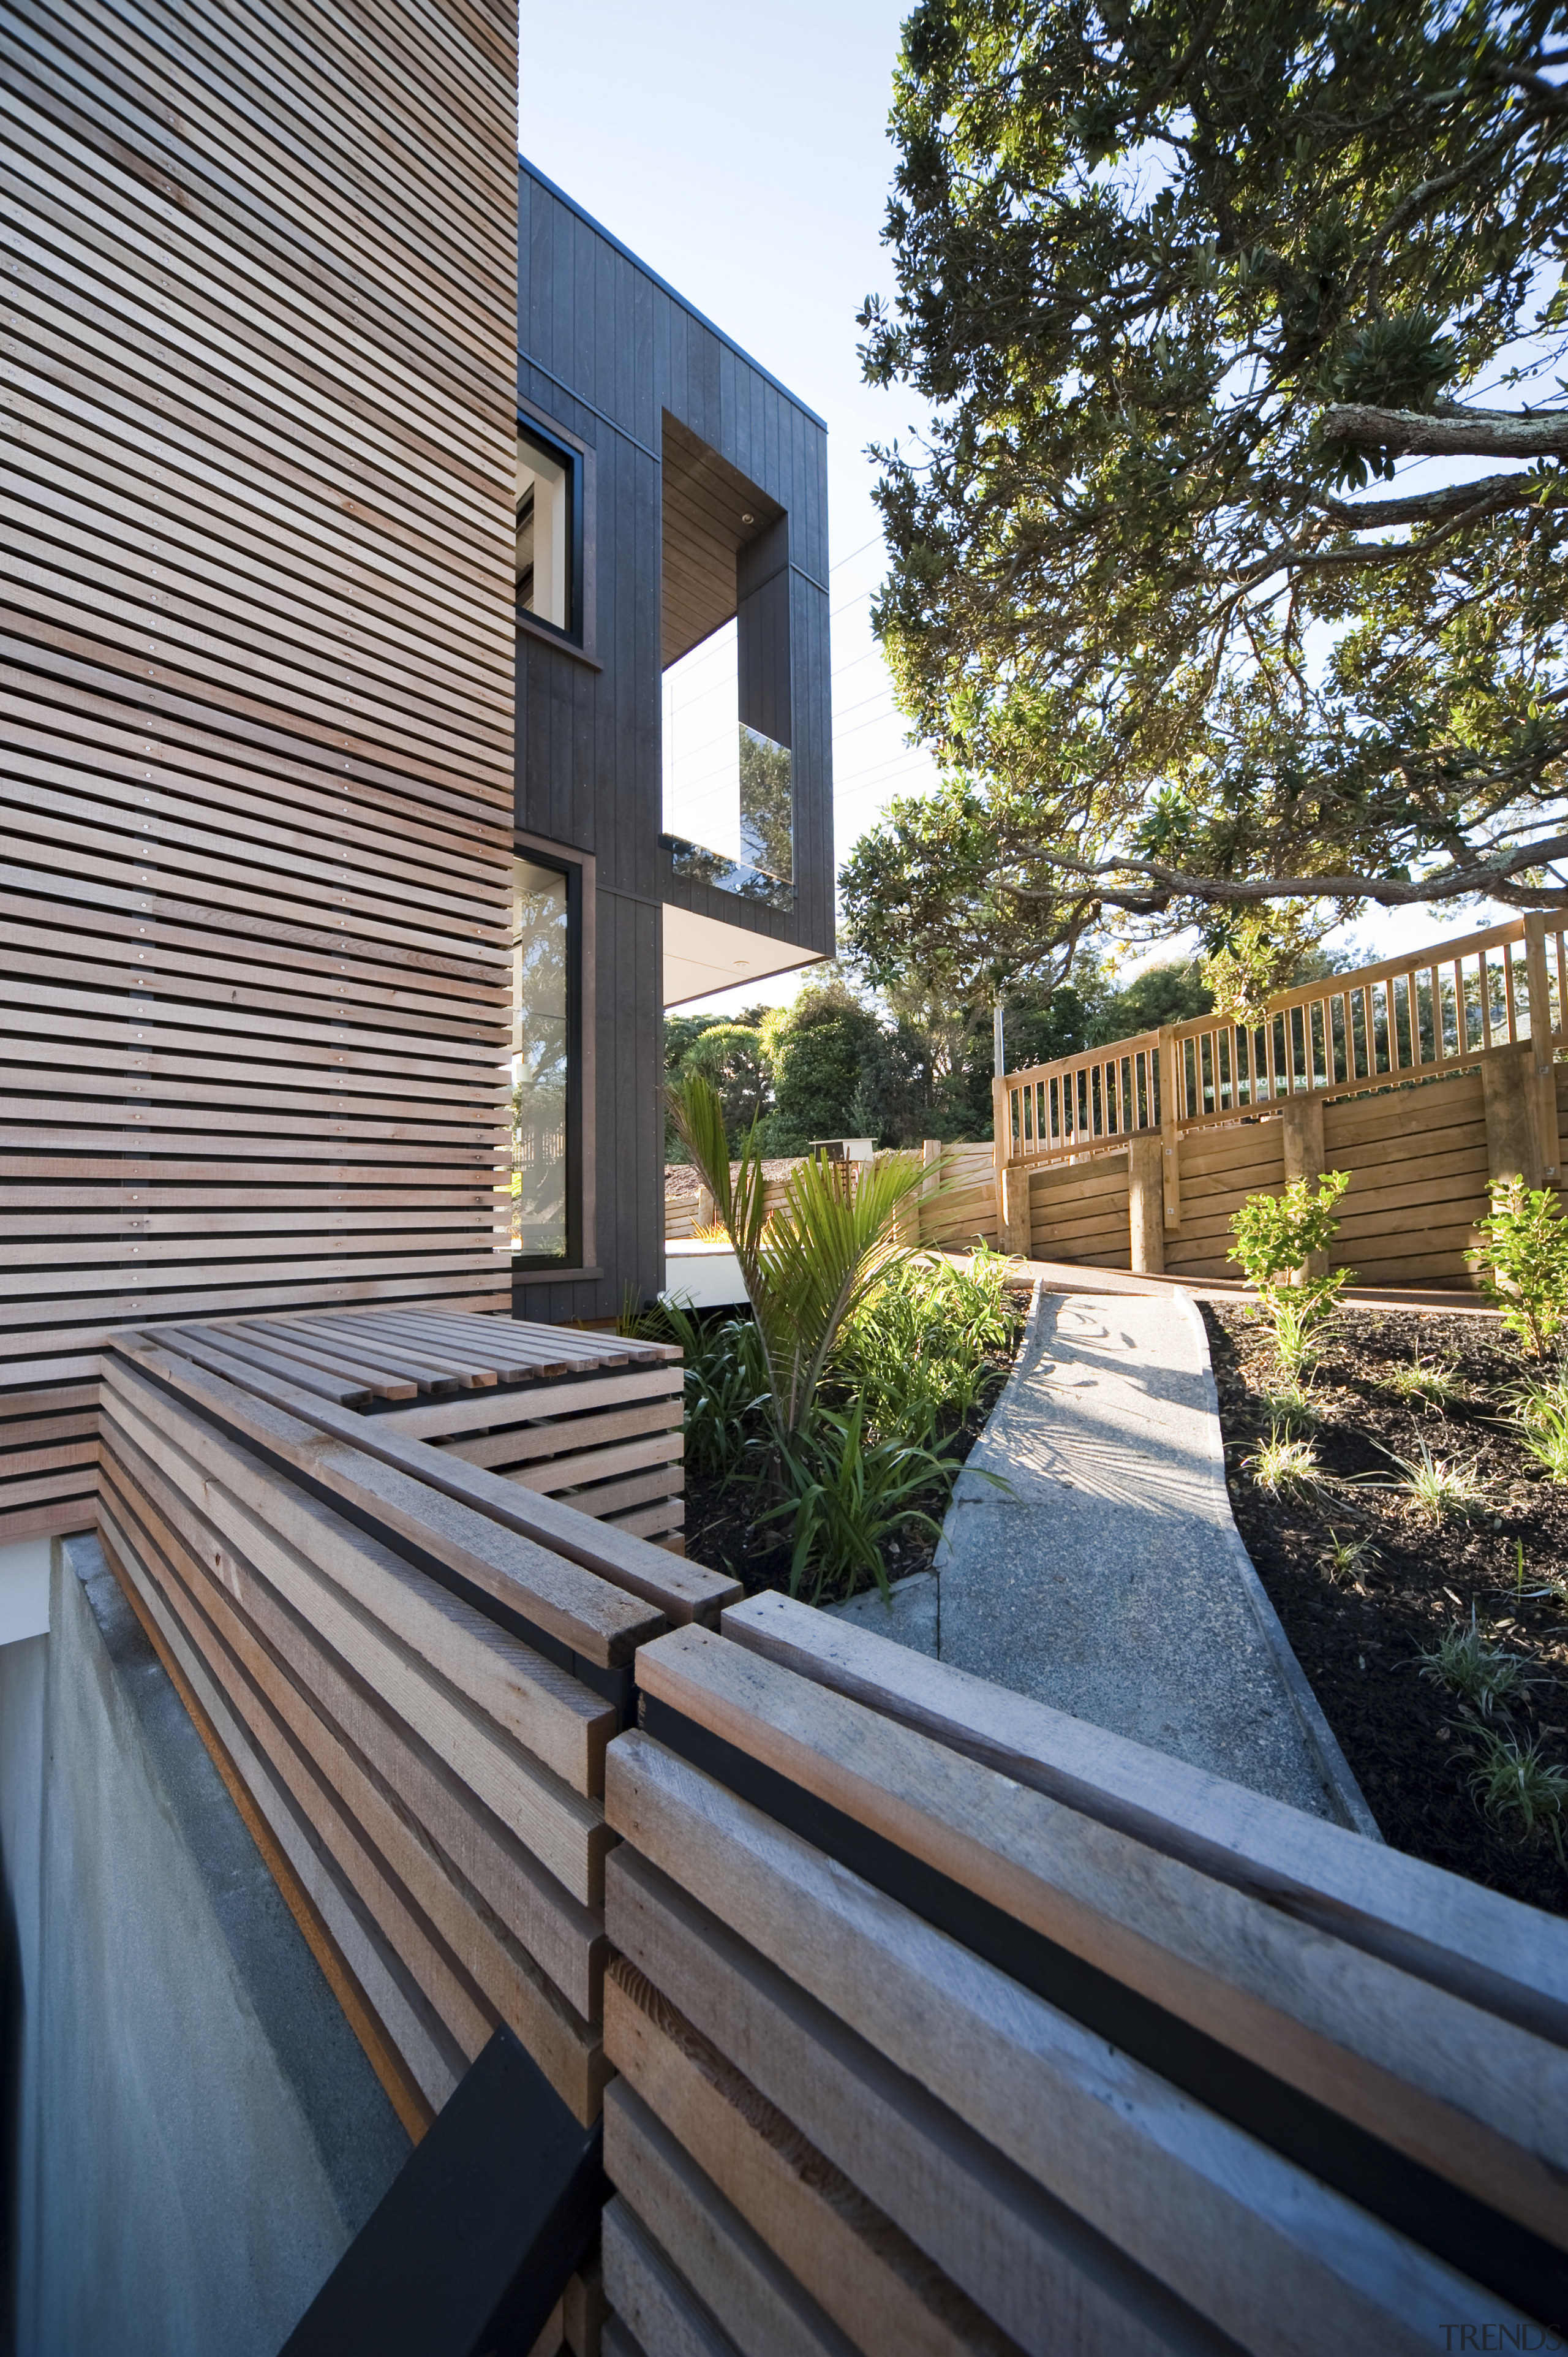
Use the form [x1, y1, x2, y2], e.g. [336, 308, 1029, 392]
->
[1205, 1303, 1568, 1914]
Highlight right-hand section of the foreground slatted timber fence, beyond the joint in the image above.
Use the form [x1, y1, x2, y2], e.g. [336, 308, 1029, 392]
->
[604, 1595, 1568, 2357]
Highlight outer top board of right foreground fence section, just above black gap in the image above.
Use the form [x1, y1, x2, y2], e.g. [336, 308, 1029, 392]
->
[639, 1631, 1568, 2241]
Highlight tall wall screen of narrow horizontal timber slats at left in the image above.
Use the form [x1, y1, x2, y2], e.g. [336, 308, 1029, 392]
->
[0, 0, 516, 1542]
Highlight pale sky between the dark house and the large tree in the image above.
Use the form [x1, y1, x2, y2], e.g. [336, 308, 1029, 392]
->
[519, 0, 1540, 1013]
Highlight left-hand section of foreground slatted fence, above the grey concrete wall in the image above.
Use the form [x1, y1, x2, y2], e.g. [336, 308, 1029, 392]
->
[99, 1325, 741, 2133]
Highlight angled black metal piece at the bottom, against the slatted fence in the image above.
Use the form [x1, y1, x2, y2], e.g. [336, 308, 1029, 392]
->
[278, 2025, 611, 2357]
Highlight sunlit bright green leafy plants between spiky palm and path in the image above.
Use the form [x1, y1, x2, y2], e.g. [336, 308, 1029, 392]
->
[830, 1247, 1019, 1433]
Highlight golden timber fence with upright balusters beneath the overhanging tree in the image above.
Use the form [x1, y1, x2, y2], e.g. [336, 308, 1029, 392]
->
[993, 917, 1568, 1287]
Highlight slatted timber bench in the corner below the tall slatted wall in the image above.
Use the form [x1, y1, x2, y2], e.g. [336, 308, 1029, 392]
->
[158, 1306, 686, 1556]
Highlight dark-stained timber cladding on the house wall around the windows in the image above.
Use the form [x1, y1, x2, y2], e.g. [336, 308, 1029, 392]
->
[516, 165, 832, 1317]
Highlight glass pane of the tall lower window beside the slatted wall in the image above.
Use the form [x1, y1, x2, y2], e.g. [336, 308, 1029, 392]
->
[511, 860, 568, 1258]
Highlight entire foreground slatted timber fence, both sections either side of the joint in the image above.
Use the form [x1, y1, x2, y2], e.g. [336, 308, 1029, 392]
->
[88, 1325, 1568, 2357]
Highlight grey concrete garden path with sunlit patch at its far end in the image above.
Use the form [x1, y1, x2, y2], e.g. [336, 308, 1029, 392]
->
[924, 1289, 1377, 1834]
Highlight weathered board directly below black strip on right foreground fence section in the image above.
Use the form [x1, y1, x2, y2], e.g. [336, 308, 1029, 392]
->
[606, 1735, 1512, 2357]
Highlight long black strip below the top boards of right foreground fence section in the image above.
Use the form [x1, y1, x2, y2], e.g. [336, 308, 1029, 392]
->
[639, 1695, 1568, 2331]
